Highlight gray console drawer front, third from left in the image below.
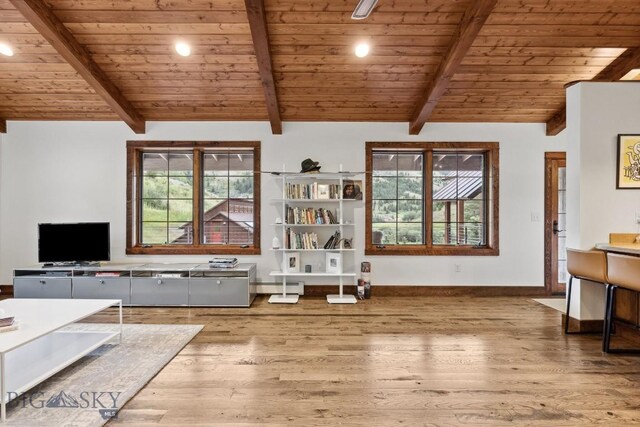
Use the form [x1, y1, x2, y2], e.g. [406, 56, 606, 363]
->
[131, 277, 189, 305]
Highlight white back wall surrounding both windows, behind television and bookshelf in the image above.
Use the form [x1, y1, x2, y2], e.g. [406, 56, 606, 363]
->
[0, 122, 565, 286]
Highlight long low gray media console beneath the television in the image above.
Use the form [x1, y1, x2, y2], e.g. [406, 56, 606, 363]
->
[13, 264, 256, 307]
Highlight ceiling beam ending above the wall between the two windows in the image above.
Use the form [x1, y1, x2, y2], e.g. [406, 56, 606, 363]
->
[244, 0, 282, 135]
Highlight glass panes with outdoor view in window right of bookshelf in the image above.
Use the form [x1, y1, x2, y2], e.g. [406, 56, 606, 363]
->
[371, 150, 486, 246]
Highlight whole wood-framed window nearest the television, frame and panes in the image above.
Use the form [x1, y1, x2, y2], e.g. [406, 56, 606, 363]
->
[126, 141, 260, 255]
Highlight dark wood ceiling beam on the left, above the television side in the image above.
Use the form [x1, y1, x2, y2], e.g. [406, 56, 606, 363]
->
[10, 0, 145, 133]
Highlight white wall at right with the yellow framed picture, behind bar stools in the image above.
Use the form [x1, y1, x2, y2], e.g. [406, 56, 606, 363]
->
[565, 82, 640, 319]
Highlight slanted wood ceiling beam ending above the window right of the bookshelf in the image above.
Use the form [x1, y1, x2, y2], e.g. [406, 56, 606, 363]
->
[409, 0, 498, 135]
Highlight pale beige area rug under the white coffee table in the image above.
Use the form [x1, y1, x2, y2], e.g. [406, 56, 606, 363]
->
[5, 323, 202, 427]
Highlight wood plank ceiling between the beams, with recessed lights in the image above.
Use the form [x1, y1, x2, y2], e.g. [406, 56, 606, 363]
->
[0, 0, 640, 133]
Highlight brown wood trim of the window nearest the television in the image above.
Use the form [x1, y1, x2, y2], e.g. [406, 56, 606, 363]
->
[125, 141, 261, 255]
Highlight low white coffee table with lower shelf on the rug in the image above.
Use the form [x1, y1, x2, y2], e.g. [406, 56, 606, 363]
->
[0, 299, 122, 422]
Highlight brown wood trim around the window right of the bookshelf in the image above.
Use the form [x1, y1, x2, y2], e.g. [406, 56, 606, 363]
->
[364, 141, 500, 256]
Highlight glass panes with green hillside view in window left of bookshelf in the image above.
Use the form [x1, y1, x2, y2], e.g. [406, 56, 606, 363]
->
[140, 150, 254, 245]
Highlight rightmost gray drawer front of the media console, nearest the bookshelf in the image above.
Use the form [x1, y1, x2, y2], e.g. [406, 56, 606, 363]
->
[189, 277, 251, 307]
